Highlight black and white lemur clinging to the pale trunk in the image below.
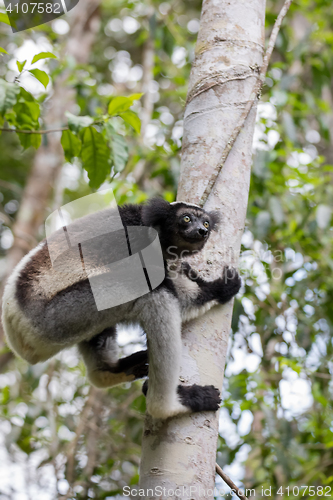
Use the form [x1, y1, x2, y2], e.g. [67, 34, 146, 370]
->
[2, 199, 241, 419]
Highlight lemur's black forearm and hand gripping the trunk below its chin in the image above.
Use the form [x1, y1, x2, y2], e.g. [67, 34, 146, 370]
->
[181, 262, 242, 306]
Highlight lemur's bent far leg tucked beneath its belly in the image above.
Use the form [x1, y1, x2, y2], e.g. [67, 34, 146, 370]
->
[79, 327, 148, 387]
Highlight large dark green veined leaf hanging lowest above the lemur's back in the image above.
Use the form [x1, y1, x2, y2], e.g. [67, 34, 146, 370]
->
[81, 127, 110, 189]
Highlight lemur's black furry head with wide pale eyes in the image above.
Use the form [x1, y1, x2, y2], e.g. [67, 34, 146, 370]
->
[142, 198, 219, 258]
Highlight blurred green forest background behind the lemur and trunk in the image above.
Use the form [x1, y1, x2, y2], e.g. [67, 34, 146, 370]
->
[0, 0, 333, 500]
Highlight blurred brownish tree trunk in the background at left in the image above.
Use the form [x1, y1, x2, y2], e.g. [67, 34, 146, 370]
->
[0, 0, 100, 371]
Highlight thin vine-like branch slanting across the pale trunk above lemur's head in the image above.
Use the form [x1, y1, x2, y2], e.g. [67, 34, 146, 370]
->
[199, 0, 292, 206]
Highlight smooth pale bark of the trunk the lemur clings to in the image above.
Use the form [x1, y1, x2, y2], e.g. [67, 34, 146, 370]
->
[140, 0, 265, 500]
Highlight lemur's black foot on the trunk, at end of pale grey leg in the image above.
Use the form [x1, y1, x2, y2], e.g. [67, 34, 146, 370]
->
[177, 384, 221, 412]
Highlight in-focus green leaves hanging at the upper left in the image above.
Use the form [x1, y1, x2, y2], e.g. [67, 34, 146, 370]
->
[0, 69, 142, 189]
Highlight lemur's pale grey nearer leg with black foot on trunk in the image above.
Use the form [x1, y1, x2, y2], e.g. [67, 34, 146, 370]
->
[140, 290, 220, 419]
